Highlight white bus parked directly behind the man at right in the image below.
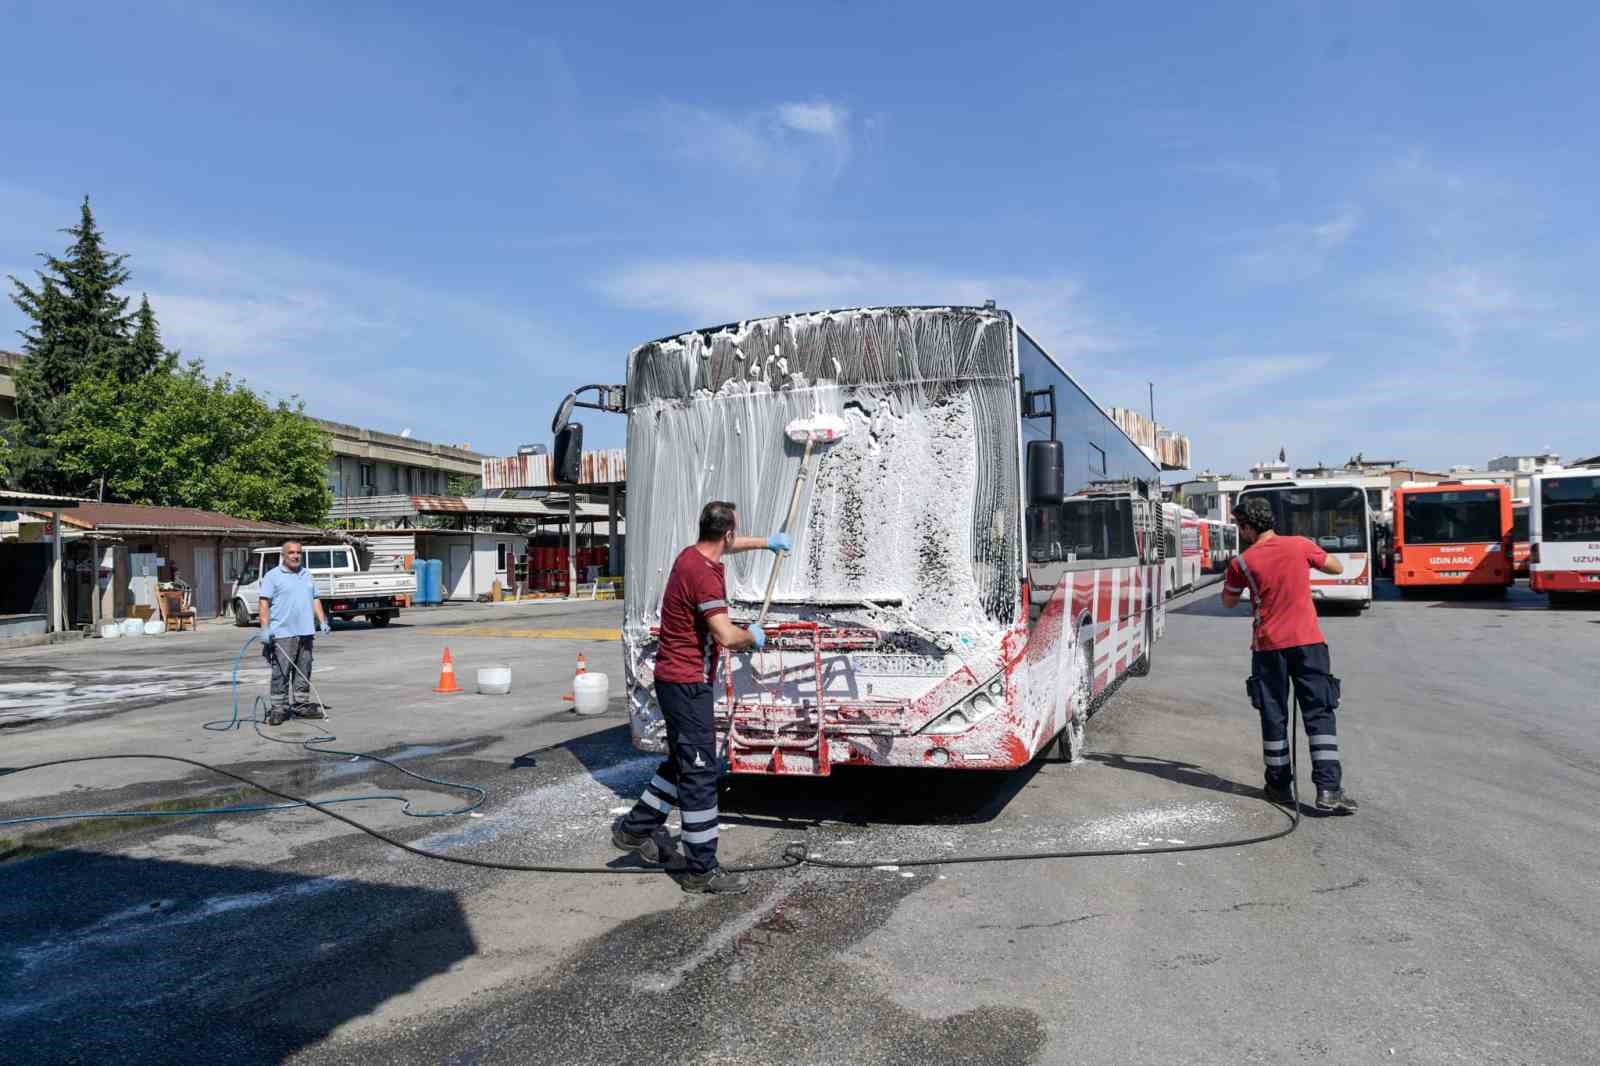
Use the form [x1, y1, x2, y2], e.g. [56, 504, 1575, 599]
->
[1238, 479, 1373, 608]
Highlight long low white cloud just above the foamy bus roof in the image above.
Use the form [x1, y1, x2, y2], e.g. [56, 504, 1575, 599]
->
[595, 258, 1136, 357]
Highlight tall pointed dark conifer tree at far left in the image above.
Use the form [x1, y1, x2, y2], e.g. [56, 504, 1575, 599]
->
[8, 197, 132, 491]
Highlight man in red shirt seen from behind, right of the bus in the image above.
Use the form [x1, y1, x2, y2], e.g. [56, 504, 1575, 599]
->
[1222, 496, 1357, 815]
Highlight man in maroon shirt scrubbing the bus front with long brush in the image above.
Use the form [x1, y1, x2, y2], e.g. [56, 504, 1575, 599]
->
[611, 499, 792, 895]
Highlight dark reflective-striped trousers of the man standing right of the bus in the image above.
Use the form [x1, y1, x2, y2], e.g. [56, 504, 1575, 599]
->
[1245, 643, 1342, 791]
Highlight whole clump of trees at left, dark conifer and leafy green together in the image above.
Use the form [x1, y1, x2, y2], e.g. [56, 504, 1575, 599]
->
[0, 198, 331, 523]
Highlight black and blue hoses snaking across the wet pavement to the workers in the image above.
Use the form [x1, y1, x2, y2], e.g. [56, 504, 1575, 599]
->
[0, 634, 1301, 874]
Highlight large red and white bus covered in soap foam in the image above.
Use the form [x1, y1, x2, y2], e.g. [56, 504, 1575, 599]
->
[582, 307, 1165, 775]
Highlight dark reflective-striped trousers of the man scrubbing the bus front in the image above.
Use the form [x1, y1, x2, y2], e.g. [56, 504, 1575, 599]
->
[622, 680, 722, 874]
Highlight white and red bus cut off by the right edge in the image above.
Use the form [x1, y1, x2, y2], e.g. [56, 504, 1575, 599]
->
[1528, 467, 1600, 603]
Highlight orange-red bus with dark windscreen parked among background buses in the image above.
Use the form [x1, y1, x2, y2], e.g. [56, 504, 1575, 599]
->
[1394, 482, 1517, 592]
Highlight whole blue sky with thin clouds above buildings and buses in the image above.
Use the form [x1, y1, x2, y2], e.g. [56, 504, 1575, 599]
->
[0, 0, 1600, 469]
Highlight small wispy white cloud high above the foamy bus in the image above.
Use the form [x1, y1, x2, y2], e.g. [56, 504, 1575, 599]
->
[645, 99, 851, 181]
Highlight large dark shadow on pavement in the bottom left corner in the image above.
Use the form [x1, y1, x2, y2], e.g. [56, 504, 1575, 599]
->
[0, 852, 477, 1063]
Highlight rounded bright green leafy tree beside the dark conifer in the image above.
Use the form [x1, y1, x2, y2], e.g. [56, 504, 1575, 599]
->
[59, 362, 333, 523]
